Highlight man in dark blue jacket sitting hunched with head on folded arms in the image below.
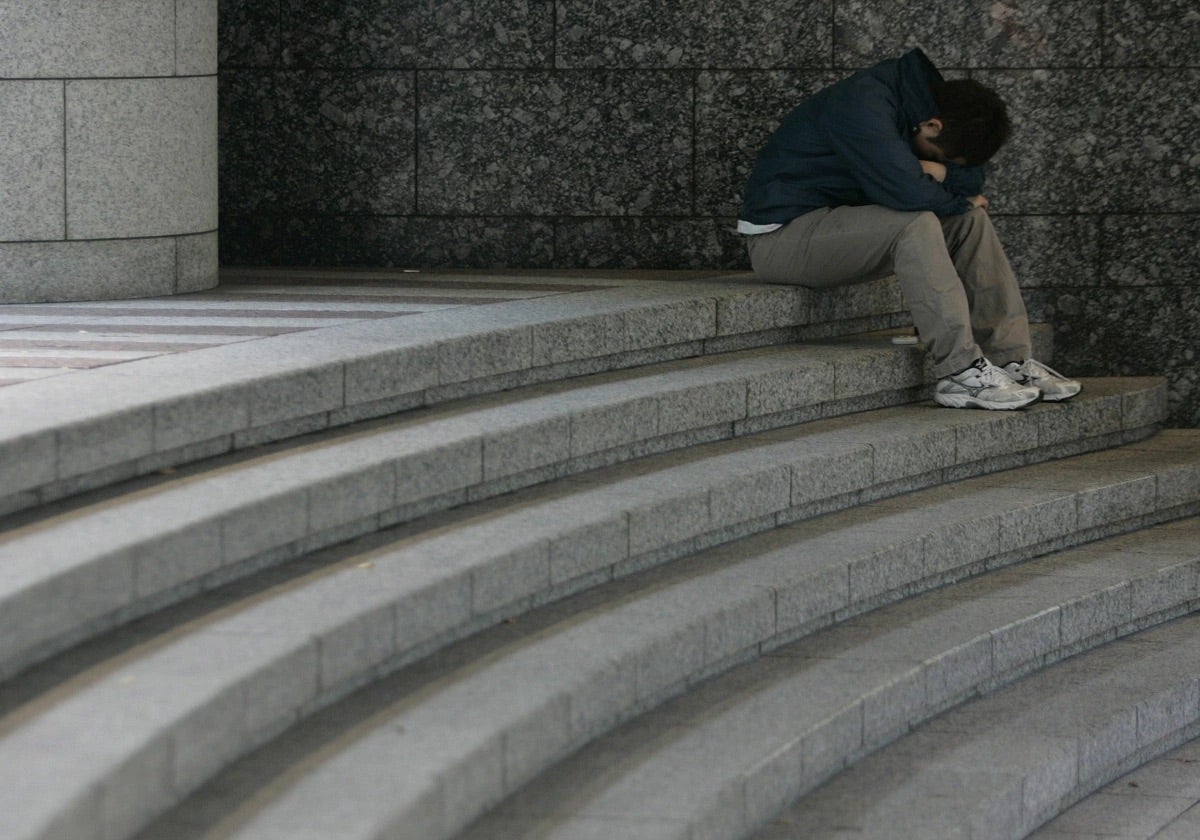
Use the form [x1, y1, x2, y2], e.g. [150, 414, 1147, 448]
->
[738, 49, 1080, 409]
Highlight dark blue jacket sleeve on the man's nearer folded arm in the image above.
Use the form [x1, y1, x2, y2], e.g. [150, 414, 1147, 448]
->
[821, 86, 972, 216]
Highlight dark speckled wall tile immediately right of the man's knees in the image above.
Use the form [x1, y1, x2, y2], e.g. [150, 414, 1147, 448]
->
[992, 215, 1100, 288]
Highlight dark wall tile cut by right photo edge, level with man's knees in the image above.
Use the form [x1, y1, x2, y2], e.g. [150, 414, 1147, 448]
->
[1100, 214, 1200, 288]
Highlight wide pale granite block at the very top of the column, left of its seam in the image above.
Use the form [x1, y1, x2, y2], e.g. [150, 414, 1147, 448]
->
[0, 0, 175, 78]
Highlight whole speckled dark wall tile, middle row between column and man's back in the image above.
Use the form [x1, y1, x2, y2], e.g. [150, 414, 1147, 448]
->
[418, 71, 692, 216]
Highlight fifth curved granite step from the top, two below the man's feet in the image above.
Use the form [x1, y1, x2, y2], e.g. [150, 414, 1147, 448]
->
[461, 516, 1200, 840]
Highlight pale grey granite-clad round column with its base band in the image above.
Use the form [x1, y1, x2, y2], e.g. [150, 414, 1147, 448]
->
[0, 0, 217, 302]
